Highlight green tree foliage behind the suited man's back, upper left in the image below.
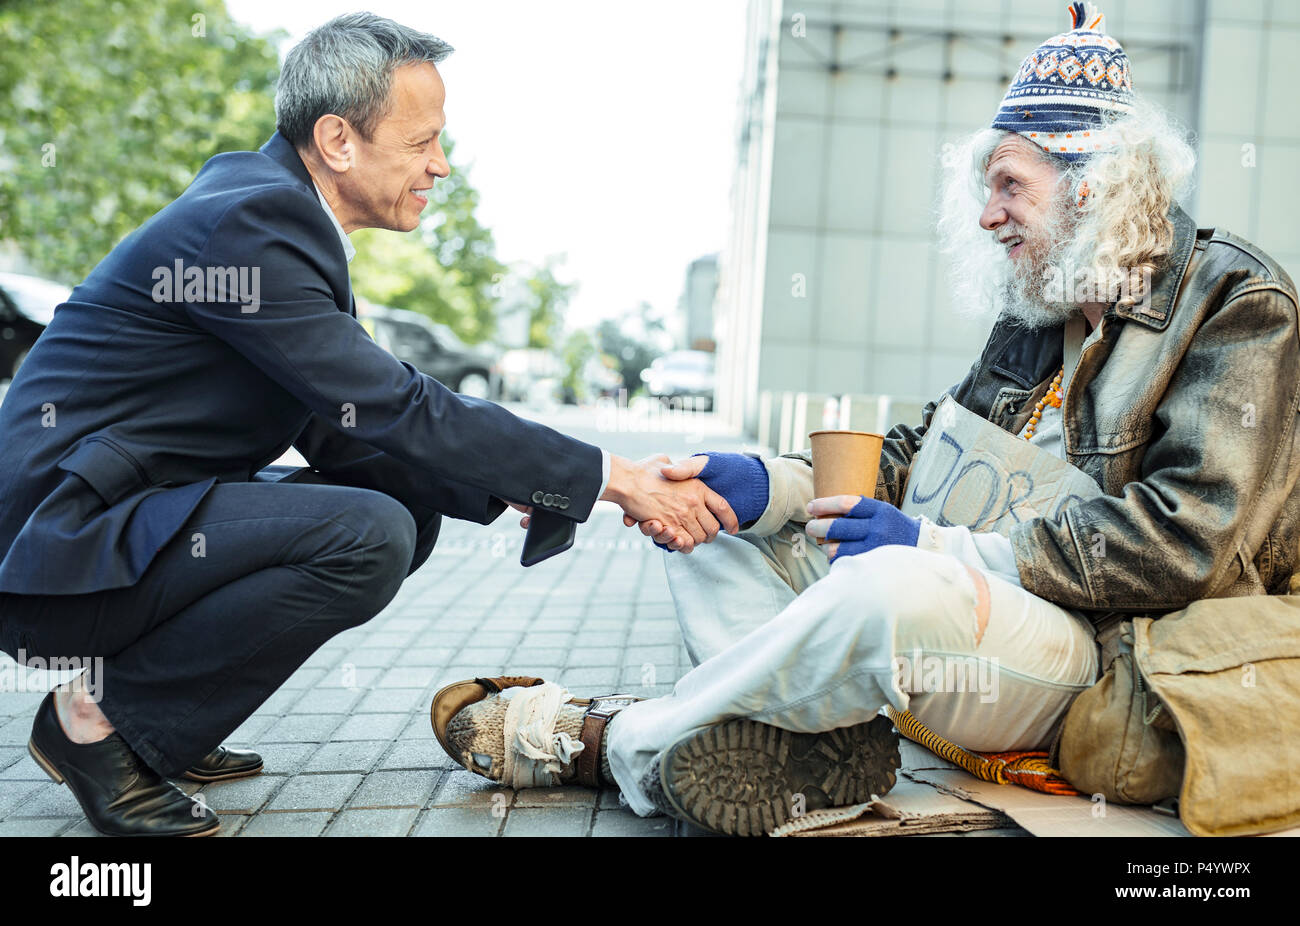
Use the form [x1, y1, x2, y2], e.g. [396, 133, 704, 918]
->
[0, 0, 280, 284]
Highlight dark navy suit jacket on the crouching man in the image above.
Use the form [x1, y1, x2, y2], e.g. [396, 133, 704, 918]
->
[0, 133, 601, 594]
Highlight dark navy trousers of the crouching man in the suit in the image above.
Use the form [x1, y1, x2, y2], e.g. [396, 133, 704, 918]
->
[0, 467, 441, 776]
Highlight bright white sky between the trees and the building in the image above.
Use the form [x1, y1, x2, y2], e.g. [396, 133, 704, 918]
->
[226, 0, 745, 325]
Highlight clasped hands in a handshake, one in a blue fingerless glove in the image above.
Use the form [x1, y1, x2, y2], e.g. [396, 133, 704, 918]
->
[514, 454, 767, 553]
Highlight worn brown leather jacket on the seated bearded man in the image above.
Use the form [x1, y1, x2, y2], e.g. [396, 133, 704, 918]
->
[876, 205, 1300, 623]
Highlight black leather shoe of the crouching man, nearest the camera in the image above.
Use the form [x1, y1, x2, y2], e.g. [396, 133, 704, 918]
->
[27, 692, 221, 836]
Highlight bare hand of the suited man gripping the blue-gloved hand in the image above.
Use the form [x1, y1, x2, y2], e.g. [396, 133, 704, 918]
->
[601, 454, 740, 553]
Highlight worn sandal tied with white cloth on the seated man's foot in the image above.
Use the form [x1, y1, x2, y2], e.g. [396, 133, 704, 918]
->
[429, 675, 645, 788]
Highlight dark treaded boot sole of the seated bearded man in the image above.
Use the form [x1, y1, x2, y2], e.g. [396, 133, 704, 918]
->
[659, 717, 900, 836]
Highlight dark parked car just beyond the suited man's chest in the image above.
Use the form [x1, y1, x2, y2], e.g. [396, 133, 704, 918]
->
[356, 299, 501, 399]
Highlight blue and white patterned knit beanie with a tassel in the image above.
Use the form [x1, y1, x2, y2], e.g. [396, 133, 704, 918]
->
[993, 3, 1134, 161]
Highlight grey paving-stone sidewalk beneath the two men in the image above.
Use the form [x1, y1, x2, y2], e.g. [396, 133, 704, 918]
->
[0, 503, 690, 836]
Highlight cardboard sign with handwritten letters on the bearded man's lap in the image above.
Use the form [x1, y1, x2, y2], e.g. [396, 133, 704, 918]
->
[901, 395, 1102, 536]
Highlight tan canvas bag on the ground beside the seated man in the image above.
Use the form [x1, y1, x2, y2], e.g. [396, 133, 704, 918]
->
[1054, 596, 1300, 836]
